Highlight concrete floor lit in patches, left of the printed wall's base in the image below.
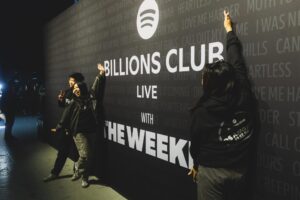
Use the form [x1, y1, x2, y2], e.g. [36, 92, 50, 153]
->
[0, 117, 125, 200]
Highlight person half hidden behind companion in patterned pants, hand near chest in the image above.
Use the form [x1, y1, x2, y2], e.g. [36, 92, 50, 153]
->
[44, 72, 84, 182]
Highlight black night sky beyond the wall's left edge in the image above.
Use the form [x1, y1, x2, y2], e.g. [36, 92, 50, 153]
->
[0, 0, 74, 80]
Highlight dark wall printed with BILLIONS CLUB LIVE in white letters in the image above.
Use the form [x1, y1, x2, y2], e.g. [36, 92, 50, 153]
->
[45, 0, 300, 200]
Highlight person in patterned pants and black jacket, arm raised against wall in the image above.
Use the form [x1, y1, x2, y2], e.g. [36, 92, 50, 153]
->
[56, 64, 105, 188]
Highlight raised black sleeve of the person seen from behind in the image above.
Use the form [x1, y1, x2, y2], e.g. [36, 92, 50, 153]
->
[226, 31, 248, 85]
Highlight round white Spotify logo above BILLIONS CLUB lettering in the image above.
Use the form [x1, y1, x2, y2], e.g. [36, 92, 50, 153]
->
[136, 0, 159, 40]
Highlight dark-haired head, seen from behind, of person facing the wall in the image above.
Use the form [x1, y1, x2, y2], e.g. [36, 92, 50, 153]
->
[202, 60, 235, 96]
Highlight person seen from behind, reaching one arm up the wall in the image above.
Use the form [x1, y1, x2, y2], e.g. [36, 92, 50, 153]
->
[189, 11, 258, 200]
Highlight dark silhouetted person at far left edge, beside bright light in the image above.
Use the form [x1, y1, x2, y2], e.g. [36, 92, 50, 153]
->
[0, 80, 17, 141]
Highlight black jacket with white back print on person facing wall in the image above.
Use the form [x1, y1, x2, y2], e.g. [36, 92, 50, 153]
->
[190, 31, 257, 168]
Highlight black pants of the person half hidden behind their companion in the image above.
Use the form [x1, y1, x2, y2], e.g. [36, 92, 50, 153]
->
[51, 132, 78, 176]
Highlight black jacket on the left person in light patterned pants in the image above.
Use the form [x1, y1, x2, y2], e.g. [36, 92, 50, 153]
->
[56, 74, 105, 135]
